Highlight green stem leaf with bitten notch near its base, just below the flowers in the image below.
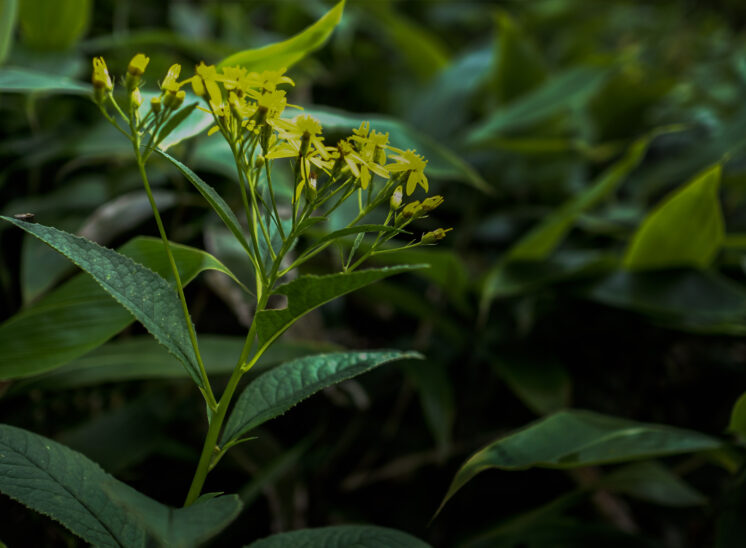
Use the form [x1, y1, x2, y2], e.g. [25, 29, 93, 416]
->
[254, 265, 426, 349]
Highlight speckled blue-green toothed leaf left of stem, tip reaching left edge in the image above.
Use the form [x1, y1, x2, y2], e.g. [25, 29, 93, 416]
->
[0, 216, 218, 386]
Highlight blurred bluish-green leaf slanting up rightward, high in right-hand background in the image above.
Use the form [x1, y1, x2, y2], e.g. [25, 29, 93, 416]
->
[467, 66, 611, 145]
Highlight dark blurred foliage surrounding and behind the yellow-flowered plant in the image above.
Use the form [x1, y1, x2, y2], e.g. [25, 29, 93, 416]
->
[0, 0, 746, 548]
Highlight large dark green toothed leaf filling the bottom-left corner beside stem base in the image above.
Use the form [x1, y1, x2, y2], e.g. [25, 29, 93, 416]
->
[0, 425, 241, 548]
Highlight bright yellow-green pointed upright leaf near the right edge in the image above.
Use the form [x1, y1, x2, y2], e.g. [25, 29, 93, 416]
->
[623, 164, 725, 270]
